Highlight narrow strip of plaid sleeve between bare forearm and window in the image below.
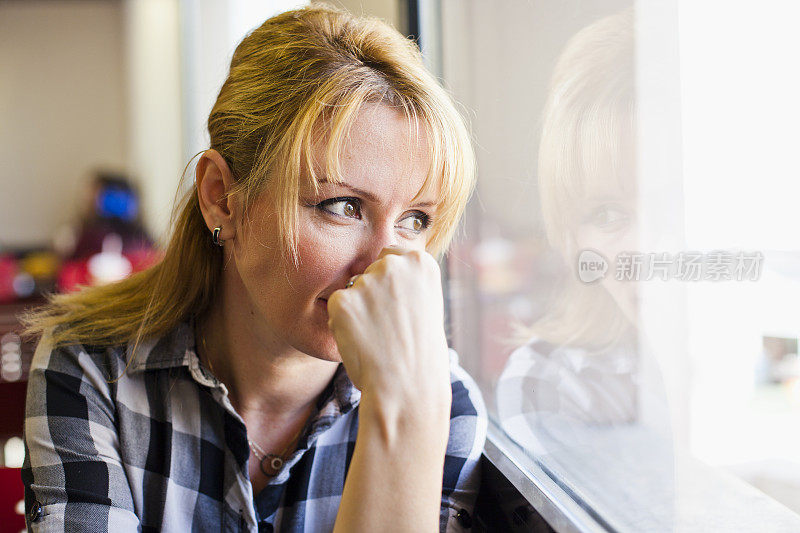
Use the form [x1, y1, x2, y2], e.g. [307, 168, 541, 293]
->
[439, 350, 487, 533]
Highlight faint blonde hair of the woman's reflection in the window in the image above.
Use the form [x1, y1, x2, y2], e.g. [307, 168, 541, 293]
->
[522, 9, 636, 350]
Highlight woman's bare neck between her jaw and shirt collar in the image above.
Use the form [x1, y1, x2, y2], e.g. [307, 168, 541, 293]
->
[195, 288, 338, 422]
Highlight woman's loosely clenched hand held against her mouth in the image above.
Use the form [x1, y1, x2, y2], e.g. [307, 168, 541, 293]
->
[328, 248, 450, 403]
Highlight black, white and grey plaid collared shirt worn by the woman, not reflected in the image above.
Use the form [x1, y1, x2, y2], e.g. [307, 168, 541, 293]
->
[22, 322, 486, 532]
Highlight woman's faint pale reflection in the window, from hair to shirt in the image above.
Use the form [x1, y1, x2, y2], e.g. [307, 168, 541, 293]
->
[497, 10, 674, 531]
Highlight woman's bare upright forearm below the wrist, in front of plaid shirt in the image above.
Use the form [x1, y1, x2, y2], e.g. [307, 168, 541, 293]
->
[334, 386, 451, 533]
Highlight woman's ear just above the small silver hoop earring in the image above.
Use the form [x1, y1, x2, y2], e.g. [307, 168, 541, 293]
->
[195, 150, 237, 241]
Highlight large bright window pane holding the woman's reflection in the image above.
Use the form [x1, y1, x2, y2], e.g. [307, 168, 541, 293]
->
[437, 0, 800, 531]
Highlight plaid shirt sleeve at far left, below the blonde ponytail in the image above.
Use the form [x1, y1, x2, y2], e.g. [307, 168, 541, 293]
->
[22, 334, 139, 532]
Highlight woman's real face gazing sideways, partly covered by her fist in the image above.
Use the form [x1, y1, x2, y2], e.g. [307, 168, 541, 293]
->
[225, 105, 436, 361]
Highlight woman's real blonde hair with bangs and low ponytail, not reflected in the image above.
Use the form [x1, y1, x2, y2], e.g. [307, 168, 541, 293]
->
[24, 5, 475, 354]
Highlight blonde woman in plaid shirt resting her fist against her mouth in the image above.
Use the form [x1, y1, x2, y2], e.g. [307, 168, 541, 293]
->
[23, 7, 485, 531]
